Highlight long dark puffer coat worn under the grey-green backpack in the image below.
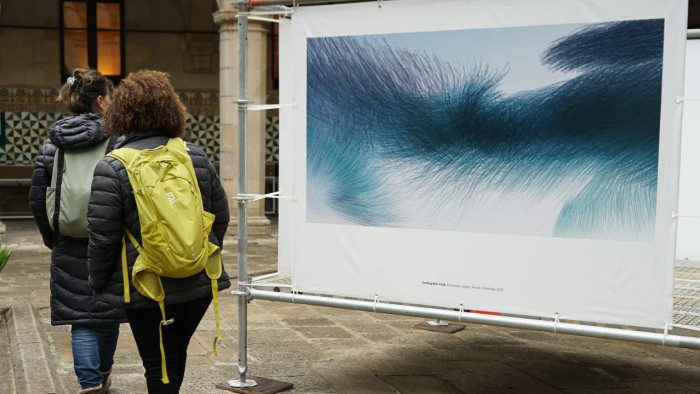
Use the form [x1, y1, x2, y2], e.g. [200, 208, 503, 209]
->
[29, 114, 126, 325]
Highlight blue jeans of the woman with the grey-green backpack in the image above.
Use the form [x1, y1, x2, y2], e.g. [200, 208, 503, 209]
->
[71, 323, 119, 390]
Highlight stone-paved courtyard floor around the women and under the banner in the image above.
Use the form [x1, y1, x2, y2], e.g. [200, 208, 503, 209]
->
[0, 221, 700, 393]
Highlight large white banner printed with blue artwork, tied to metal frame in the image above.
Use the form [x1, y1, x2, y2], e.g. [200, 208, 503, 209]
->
[280, 0, 687, 327]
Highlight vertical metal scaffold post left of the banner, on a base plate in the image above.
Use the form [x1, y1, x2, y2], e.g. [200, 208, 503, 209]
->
[229, 5, 257, 388]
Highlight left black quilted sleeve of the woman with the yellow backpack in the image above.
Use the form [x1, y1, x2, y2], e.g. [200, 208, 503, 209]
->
[87, 157, 124, 292]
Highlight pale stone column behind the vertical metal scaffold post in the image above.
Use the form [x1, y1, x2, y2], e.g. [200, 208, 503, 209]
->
[214, 4, 270, 235]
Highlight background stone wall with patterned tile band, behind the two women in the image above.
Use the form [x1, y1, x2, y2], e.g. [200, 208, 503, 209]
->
[0, 0, 278, 219]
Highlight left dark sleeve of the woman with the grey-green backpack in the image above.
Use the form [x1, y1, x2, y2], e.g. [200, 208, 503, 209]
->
[29, 140, 56, 249]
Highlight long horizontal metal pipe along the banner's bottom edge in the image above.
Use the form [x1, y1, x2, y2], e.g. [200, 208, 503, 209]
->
[250, 288, 700, 349]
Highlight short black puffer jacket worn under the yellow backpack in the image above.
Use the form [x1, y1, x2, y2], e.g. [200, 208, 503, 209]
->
[88, 132, 231, 308]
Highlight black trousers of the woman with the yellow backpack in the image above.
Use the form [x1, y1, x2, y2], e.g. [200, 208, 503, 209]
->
[126, 297, 211, 394]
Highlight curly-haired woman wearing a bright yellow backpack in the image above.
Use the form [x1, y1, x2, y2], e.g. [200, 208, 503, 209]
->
[87, 70, 231, 393]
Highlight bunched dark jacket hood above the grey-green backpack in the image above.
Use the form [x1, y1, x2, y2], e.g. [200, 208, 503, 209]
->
[49, 114, 107, 150]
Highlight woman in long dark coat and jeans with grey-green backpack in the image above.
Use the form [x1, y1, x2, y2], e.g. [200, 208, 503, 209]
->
[29, 69, 126, 393]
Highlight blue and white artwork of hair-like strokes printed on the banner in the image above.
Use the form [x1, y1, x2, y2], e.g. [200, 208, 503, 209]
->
[306, 19, 664, 242]
